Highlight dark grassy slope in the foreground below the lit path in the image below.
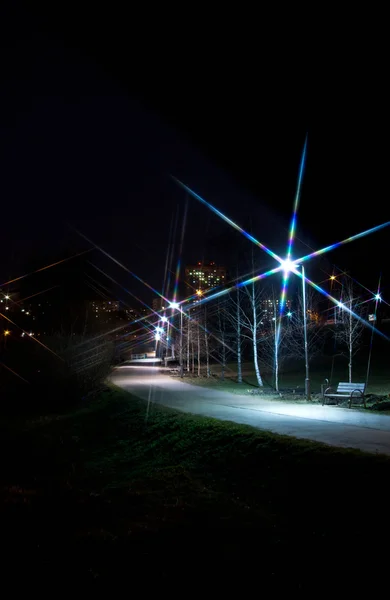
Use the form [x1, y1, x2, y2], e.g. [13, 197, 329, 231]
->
[1, 389, 390, 595]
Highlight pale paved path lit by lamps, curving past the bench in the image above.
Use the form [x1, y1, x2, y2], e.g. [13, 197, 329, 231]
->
[111, 366, 390, 455]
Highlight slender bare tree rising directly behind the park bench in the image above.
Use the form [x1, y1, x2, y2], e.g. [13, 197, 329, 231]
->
[336, 279, 366, 383]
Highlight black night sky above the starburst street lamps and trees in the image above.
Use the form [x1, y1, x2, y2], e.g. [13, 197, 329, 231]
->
[0, 3, 390, 300]
